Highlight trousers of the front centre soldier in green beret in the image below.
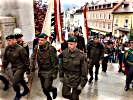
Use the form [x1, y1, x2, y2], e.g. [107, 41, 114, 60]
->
[62, 84, 81, 100]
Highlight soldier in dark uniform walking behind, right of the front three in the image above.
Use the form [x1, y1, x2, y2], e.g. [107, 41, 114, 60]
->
[87, 37, 104, 83]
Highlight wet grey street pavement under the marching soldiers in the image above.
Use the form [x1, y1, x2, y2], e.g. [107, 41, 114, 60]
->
[0, 64, 133, 100]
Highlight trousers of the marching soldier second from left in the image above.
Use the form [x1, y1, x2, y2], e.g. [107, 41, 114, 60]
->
[39, 75, 57, 100]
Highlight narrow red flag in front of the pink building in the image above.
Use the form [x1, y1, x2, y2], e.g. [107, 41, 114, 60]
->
[83, 5, 89, 43]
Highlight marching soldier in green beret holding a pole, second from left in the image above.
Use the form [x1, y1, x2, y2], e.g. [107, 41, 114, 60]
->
[31, 33, 58, 100]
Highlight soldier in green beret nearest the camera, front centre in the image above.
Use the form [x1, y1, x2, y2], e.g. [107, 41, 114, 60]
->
[59, 36, 88, 100]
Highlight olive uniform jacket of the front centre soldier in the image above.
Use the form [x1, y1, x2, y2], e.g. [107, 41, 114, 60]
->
[59, 49, 88, 88]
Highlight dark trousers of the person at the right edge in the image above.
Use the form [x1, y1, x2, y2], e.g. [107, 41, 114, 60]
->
[126, 66, 133, 87]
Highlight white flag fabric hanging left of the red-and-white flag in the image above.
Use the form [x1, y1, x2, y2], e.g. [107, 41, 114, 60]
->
[42, 0, 54, 37]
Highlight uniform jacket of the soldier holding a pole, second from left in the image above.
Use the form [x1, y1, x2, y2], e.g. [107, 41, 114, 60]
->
[31, 42, 58, 79]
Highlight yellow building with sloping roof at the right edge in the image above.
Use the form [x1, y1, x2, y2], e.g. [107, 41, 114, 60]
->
[112, 2, 133, 37]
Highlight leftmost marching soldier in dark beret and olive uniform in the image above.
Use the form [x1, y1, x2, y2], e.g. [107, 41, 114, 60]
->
[2, 35, 29, 100]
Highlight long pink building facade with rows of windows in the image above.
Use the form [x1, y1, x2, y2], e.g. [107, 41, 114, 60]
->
[87, 2, 118, 35]
